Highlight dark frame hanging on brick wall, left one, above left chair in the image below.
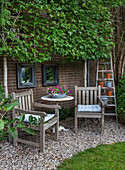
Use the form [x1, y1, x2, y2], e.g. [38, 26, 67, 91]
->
[17, 63, 36, 88]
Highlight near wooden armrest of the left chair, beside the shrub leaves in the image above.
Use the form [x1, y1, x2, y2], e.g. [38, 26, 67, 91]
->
[15, 109, 47, 117]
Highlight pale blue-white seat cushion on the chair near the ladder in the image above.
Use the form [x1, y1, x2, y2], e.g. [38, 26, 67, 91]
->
[78, 105, 101, 112]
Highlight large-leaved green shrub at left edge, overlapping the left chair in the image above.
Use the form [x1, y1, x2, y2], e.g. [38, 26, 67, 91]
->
[0, 86, 37, 141]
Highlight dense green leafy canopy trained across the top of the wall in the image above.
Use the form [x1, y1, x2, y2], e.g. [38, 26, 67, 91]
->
[0, 0, 123, 62]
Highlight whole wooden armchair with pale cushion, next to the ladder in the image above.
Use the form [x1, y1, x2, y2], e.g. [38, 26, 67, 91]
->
[75, 86, 104, 135]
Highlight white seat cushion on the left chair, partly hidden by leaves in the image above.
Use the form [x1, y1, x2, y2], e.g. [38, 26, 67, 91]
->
[18, 114, 54, 122]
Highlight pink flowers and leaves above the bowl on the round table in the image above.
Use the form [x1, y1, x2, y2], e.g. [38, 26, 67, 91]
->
[48, 85, 71, 95]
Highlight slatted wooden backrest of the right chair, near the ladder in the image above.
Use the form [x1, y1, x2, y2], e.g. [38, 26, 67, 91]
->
[75, 86, 101, 105]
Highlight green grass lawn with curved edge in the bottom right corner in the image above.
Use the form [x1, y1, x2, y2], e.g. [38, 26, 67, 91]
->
[57, 142, 125, 170]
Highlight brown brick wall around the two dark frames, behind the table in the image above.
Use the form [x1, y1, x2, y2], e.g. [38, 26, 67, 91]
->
[0, 57, 84, 107]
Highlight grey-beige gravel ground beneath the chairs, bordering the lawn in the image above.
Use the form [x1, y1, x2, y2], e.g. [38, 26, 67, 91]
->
[0, 117, 125, 170]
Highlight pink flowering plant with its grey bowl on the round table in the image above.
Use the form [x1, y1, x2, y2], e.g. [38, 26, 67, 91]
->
[48, 85, 71, 98]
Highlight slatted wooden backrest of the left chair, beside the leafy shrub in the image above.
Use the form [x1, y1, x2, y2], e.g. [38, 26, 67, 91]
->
[12, 89, 34, 111]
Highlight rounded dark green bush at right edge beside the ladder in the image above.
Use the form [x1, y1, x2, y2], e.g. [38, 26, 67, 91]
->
[116, 73, 125, 123]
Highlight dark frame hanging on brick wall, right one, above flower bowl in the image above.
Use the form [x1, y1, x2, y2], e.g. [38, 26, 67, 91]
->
[42, 64, 59, 86]
